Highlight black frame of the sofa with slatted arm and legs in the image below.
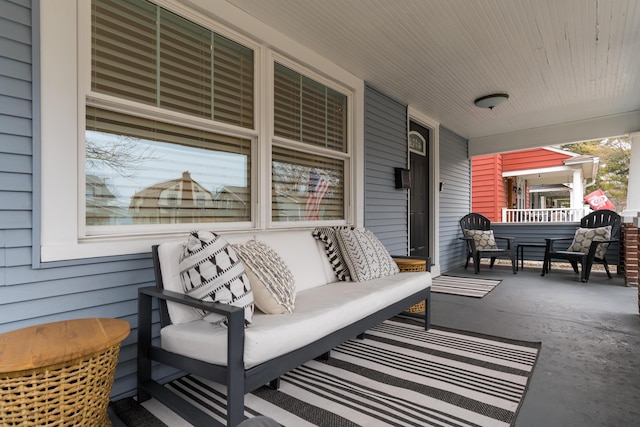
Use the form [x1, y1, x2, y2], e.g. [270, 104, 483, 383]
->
[138, 246, 431, 427]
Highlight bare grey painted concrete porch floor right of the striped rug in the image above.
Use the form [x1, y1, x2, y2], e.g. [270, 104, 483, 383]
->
[432, 263, 640, 427]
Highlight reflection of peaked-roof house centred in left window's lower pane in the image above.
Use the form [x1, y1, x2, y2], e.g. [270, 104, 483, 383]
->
[129, 172, 221, 224]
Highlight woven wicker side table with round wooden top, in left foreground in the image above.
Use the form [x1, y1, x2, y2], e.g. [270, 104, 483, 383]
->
[0, 318, 130, 427]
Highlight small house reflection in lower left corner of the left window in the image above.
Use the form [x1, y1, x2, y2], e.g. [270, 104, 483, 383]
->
[85, 175, 127, 225]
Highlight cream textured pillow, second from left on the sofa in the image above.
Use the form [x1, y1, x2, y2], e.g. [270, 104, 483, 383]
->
[234, 240, 296, 314]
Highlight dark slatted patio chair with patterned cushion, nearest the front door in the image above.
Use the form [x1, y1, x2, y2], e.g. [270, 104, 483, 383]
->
[460, 212, 518, 274]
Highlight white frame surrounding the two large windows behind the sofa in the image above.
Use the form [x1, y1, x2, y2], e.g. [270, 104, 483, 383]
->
[40, 0, 364, 262]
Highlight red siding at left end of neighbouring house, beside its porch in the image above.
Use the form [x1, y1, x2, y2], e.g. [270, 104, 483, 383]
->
[471, 154, 506, 222]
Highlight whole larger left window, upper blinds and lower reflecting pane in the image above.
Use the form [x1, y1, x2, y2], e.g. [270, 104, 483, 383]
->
[85, 0, 254, 234]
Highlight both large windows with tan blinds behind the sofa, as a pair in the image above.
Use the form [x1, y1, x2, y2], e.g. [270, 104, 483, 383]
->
[85, 0, 351, 235]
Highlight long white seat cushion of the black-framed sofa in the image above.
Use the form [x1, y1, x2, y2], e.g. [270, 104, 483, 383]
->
[161, 272, 431, 368]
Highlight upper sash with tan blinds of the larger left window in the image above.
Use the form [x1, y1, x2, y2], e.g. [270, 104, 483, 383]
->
[91, 0, 254, 129]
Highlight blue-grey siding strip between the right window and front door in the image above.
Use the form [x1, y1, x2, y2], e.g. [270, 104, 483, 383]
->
[364, 85, 408, 255]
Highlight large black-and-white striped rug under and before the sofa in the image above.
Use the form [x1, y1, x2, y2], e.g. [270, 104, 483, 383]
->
[156, 316, 540, 427]
